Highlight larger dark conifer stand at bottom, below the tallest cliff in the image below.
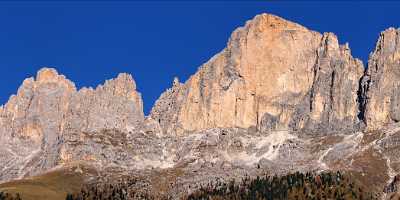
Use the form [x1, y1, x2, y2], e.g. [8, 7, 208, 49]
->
[186, 172, 375, 200]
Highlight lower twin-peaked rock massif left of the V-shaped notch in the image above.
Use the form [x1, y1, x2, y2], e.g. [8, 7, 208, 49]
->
[0, 68, 144, 178]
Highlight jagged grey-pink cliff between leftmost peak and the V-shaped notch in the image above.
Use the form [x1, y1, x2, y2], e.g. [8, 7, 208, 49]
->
[65, 74, 144, 132]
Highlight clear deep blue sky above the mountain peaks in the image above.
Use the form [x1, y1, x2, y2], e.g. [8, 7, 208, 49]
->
[0, 1, 400, 113]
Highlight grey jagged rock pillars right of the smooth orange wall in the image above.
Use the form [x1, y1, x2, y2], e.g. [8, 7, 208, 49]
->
[289, 33, 364, 132]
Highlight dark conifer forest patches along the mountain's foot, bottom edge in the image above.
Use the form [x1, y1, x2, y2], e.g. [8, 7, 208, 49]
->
[66, 171, 376, 200]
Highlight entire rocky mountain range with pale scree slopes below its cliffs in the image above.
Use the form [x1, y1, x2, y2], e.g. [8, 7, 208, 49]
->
[0, 14, 400, 199]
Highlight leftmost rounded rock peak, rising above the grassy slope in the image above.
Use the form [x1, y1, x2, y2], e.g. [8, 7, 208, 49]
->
[0, 68, 76, 179]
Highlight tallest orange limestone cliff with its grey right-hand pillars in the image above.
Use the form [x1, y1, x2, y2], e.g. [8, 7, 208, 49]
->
[151, 14, 363, 134]
